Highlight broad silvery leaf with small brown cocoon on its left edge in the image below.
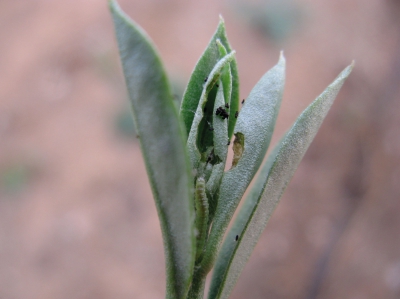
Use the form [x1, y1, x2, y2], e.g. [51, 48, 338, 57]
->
[197, 55, 285, 274]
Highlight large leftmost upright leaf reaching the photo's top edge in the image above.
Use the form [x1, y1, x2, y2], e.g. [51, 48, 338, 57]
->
[109, 1, 195, 299]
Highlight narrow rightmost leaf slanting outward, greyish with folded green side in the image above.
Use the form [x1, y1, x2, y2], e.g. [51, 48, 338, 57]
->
[208, 65, 353, 299]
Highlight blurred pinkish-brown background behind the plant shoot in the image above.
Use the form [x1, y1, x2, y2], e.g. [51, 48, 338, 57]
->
[0, 0, 400, 299]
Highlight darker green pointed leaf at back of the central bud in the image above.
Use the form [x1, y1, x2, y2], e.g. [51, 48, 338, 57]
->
[180, 17, 239, 141]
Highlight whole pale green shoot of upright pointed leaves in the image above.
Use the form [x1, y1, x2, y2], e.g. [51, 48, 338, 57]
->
[110, 1, 352, 299]
